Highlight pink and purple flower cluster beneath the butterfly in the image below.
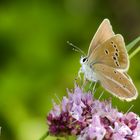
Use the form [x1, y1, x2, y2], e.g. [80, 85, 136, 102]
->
[47, 86, 140, 140]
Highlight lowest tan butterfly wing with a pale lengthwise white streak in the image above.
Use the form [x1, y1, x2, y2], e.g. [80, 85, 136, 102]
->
[94, 64, 138, 101]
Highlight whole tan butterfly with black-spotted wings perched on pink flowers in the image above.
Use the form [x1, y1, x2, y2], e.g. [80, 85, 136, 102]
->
[79, 19, 138, 101]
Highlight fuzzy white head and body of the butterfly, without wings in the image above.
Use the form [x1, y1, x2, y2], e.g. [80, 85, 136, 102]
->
[80, 57, 98, 82]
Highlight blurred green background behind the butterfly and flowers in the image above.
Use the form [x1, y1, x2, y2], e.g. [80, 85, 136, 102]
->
[0, 0, 140, 140]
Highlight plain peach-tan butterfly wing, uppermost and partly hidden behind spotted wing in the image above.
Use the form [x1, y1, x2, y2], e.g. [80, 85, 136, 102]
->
[88, 19, 114, 56]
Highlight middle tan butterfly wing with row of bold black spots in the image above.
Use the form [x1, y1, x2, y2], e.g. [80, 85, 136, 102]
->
[88, 34, 129, 71]
